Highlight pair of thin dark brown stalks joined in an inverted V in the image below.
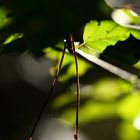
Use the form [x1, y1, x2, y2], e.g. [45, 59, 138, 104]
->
[29, 35, 80, 140]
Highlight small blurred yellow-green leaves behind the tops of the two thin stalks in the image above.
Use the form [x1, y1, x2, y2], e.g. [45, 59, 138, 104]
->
[44, 41, 91, 81]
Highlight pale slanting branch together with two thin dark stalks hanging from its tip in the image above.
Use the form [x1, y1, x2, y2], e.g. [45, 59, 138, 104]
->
[29, 35, 140, 140]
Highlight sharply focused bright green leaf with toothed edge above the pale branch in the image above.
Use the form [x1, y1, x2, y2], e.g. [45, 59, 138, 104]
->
[83, 20, 140, 53]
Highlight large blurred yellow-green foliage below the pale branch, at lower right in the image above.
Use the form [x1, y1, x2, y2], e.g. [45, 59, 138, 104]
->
[51, 77, 140, 140]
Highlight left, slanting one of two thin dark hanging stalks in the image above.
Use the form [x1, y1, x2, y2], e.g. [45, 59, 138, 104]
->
[29, 42, 67, 140]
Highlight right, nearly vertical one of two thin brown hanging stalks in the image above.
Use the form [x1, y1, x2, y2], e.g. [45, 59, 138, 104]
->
[70, 36, 80, 140]
